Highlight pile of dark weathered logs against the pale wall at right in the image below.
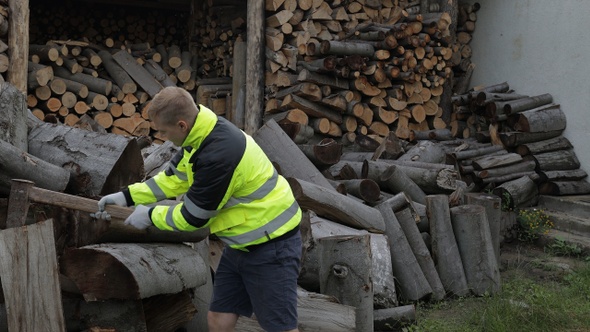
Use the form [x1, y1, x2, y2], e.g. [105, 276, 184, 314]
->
[449, 82, 590, 207]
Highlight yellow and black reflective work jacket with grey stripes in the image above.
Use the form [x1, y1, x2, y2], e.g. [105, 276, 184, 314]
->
[125, 105, 301, 249]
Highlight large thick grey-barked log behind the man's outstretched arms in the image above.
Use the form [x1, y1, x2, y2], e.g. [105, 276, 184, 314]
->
[29, 123, 143, 197]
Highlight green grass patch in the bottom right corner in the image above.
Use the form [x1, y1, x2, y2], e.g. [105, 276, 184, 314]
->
[403, 260, 590, 332]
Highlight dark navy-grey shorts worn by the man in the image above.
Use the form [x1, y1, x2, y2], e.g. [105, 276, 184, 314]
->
[209, 231, 302, 331]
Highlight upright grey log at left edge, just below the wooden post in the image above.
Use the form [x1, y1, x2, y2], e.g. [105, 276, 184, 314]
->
[0, 82, 28, 152]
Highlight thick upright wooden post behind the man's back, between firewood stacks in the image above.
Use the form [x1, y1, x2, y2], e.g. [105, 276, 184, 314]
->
[244, 0, 266, 134]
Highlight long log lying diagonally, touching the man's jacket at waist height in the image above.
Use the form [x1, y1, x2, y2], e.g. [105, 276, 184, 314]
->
[287, 177, 385, 233]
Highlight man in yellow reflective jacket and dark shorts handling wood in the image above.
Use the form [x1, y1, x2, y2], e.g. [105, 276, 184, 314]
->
[96, 87, 301, 332]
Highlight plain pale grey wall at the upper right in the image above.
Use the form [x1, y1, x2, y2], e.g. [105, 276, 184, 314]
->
[462, 0, 590, 172]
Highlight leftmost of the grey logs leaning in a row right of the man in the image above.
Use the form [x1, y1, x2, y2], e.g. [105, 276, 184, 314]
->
[375, 200, 432, 301]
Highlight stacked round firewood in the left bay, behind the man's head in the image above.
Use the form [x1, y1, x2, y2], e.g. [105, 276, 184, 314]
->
[27, 5, 197, 140]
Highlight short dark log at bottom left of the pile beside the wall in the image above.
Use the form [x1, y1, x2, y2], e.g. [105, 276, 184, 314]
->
[492, 176, 539, 209]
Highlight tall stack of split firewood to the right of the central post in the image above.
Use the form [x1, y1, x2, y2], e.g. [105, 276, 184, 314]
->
[265, 1, 476, 145]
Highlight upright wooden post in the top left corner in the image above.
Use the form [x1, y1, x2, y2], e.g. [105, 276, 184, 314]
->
[8, 0, 29, 95]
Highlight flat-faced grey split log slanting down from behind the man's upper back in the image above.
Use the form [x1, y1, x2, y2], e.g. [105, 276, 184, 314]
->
[252, 120, 334, 190]
